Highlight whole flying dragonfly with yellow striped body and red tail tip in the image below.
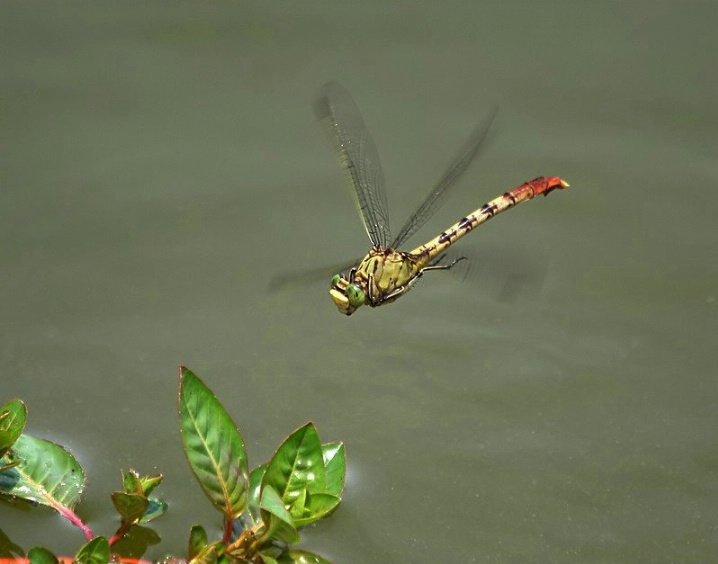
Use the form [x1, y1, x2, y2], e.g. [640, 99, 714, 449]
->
[314, 82, 569, 315]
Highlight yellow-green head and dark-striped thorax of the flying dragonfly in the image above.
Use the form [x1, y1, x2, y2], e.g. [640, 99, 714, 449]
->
[329, 247, 420, 315]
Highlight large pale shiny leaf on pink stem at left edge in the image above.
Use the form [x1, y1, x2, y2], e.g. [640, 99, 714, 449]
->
[0, 435, 85, 513]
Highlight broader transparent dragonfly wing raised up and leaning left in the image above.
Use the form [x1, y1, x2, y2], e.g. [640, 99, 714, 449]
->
[314, 82, 391, 248]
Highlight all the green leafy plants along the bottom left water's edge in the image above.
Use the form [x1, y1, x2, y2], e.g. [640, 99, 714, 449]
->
[0, 367, 346, 564]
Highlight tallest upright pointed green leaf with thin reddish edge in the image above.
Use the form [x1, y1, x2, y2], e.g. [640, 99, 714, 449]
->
[179, 367, 248, 520]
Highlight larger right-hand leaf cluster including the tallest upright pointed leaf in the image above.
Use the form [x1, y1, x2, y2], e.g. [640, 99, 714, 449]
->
[179, 367, 346, 564]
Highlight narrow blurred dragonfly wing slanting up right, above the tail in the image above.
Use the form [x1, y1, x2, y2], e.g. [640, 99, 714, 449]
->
[391, 108, 498, 249]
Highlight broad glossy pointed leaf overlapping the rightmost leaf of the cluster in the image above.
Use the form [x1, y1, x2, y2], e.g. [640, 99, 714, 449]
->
[262, 423, 326, 507]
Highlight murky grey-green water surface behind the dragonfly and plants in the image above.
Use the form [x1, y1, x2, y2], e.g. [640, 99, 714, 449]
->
[0, 1, 718, 563]
